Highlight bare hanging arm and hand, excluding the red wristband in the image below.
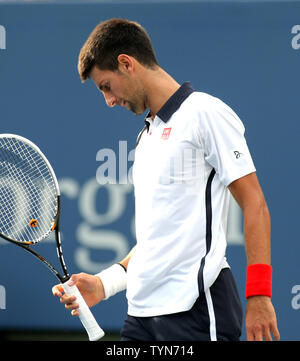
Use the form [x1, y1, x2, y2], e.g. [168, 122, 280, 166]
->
[229, 173, 280, 341]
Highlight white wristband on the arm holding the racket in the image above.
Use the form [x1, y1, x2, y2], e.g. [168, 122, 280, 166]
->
[95, 263, 127, 300]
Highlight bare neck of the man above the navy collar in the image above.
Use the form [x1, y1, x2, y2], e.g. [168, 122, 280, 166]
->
[142, 67, 180, 118]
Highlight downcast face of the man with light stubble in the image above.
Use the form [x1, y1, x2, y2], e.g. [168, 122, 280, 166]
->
[90, 66, 146, 115]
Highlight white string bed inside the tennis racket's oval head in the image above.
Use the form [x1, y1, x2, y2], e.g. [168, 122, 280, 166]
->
[0, 138, 57, 243]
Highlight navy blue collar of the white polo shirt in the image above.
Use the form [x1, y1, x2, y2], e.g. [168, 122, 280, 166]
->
[145, 82, 194, 128]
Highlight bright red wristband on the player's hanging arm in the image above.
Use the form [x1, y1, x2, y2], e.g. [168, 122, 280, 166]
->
[246, 263, 272, 298]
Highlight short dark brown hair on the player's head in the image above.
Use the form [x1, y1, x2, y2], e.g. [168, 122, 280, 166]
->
[78, 19, 158, 82]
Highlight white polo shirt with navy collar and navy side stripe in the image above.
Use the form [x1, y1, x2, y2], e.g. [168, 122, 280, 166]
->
[127, 83, 255, 316]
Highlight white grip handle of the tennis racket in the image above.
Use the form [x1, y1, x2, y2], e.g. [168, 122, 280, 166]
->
[62, 281, 104, 341]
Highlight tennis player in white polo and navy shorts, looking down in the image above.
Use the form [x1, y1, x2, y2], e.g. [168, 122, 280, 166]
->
[52, 19, 280, 341]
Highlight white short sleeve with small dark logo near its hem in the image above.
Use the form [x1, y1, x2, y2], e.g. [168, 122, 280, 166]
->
[198, 97, 256, 186]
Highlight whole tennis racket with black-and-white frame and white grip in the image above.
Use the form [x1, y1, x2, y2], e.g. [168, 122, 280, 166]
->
[0, 134, 104, 341]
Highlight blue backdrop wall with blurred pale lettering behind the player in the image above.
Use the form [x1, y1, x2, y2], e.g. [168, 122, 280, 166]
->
[0, 1, 300, 340]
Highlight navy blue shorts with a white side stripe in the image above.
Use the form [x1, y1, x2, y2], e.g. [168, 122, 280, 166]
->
[121, 268, 243, 341]
